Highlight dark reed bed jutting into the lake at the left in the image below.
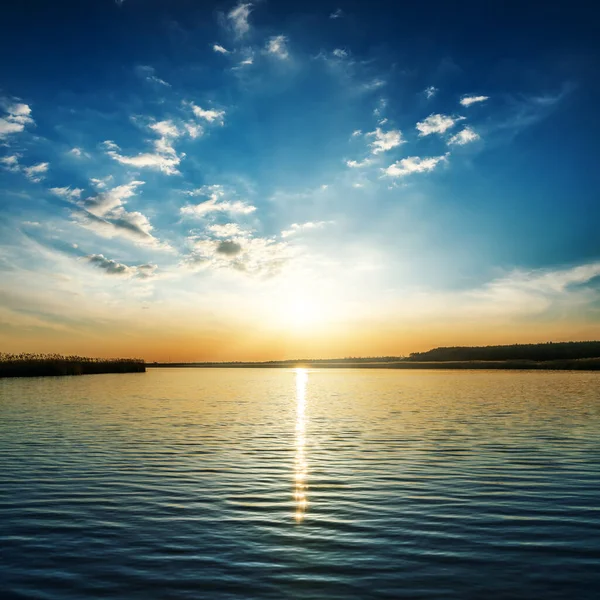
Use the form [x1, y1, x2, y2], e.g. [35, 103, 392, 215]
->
[0, 352, 146, 377]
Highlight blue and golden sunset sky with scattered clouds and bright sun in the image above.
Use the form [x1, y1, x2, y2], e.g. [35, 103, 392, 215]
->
[0, 0, 600, 361]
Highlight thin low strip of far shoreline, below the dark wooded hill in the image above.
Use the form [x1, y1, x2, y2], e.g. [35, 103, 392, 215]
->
[146, 358, 600, 371]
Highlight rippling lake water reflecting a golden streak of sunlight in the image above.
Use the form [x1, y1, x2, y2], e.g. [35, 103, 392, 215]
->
[0, 369, 600, 600]
